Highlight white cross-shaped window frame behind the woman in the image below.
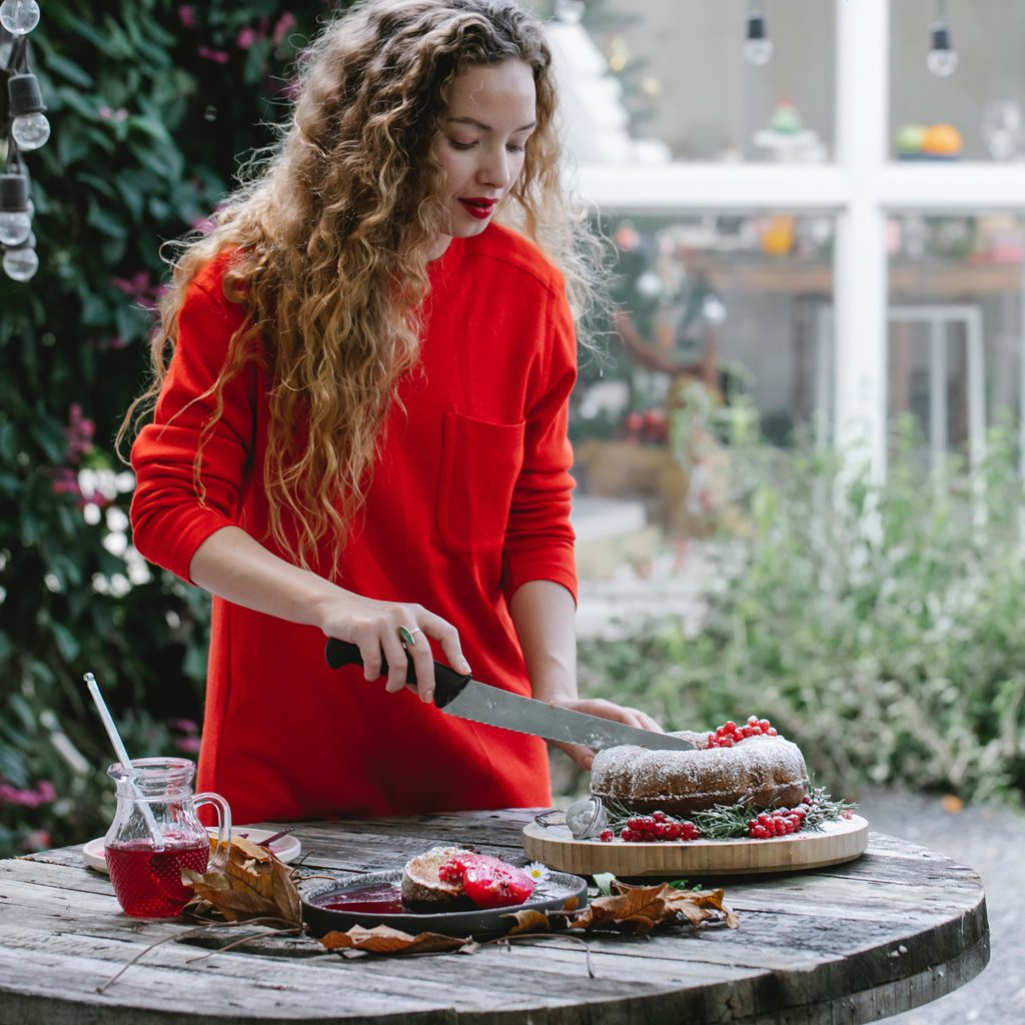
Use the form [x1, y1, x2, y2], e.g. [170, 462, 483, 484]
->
[578, 0, 1025, 479]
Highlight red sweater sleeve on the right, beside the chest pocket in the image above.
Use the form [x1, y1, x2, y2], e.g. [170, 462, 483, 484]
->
[502, 282, 577, 601]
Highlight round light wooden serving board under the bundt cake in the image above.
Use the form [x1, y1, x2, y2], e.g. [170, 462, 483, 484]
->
[523, 815, 868, 877]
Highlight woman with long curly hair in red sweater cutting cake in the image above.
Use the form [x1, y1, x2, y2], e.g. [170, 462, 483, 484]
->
[124, 0, 658, 822]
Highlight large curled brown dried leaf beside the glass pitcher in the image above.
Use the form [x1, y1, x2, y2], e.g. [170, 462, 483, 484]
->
[181, 836, 302, 928]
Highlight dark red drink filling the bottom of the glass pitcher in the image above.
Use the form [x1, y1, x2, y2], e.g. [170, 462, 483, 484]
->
[106, 836, 210, 918]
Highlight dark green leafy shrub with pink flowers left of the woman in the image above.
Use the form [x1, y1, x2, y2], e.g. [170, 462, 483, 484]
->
[0, 0, 329, 856]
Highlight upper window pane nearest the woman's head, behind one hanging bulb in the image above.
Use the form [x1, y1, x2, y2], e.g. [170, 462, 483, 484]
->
[539, 0, 835, 163]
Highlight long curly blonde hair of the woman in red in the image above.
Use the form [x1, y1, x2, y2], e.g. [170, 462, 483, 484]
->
[119, 0, 595, 567]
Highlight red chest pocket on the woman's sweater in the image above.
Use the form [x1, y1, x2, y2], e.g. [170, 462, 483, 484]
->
[438, 410, 526, 551]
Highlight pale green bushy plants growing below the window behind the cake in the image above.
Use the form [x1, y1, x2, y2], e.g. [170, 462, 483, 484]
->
[580, 423, 1025, 798]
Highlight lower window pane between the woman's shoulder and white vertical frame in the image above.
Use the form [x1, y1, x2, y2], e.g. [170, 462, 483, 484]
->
[571, 213, 833, 576]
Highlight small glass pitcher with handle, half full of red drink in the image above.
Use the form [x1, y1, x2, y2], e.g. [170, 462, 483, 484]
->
[104, 759, 232, 918]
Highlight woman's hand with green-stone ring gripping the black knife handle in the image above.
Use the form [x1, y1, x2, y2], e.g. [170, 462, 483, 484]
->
[320, 591, 470, 701]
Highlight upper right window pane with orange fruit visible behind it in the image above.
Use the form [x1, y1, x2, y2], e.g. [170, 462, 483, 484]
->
[890, 0, 1025, 160]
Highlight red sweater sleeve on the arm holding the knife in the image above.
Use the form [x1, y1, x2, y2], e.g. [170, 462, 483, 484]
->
[131, 281, 256, 580]
